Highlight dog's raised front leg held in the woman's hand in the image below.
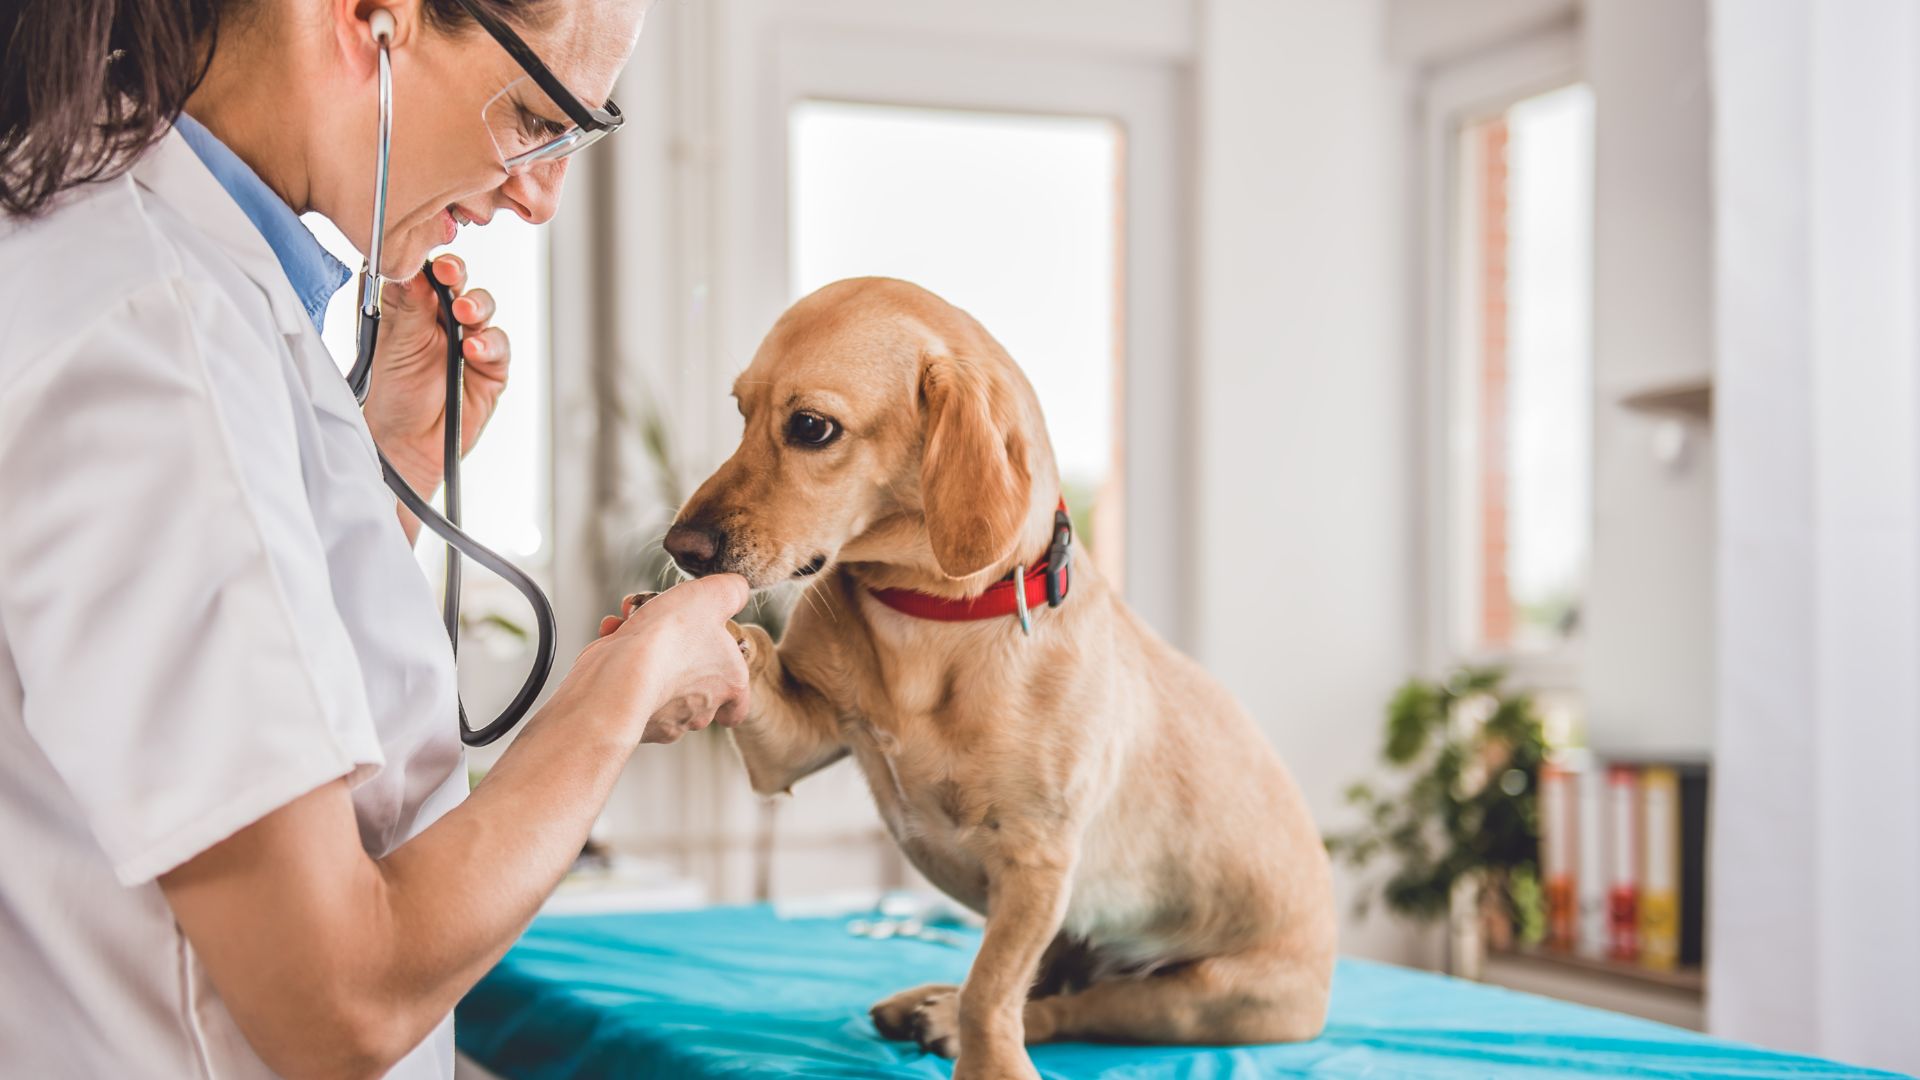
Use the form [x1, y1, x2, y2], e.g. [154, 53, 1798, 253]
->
[733, 626, 847, 796]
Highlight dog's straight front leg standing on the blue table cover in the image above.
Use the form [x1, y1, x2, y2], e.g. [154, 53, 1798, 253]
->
[954, 837, 1073, 1080]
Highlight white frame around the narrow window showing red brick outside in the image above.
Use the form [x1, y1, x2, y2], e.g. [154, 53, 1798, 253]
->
[1419, 27, 1586, 692]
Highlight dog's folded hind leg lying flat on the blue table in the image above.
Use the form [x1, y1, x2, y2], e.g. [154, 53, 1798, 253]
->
[1025, 951, 1332, 1045]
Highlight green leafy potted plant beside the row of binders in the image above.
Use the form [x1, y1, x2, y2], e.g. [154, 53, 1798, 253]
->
[1327, 667, 1548, 969]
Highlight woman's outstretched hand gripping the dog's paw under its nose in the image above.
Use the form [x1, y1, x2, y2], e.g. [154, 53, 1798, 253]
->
[555, 575, 749, 742]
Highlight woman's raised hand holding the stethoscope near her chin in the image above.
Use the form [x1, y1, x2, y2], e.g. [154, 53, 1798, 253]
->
[365, 256, 511, 518]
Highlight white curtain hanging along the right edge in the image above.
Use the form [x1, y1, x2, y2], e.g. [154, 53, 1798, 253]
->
[1707, 0, 1920, 1074]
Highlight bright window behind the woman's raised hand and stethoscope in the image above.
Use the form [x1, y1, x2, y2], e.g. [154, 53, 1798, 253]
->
[305, 213, 553, 557]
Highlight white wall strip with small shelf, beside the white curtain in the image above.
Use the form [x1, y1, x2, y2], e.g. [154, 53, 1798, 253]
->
[1582, 0, 1715, 757]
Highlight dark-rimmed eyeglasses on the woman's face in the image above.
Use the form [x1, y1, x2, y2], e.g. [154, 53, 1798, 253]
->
[455, 0, 626, 173]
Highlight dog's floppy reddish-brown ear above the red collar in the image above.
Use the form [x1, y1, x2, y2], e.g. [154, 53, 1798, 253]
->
[920, 354, 1033, 578]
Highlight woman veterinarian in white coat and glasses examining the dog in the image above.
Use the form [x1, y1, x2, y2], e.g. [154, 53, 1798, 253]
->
[0, 0, 747, 1078]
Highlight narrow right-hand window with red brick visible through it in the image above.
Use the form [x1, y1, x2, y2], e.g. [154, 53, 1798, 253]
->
[1448, 85, 1594, 657]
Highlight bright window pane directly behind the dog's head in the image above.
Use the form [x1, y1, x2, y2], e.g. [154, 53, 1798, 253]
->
[789, 100, 1123, 582]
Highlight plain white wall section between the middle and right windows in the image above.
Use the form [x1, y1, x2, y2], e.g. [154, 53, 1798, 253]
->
[1192, 0, 1425, 961]
